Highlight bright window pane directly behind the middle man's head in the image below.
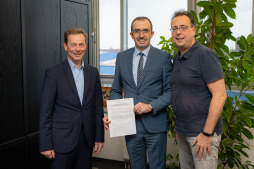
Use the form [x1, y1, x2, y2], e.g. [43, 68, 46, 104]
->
[128, 0, 187, 48]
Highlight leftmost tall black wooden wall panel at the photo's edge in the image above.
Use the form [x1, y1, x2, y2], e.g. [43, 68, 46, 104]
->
[0, 0, 24, 144]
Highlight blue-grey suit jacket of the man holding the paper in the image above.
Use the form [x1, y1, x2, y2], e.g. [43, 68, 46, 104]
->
[110, 46, 172, 133]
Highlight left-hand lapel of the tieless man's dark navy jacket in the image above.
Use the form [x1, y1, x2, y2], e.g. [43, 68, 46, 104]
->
[64, 59, 80, 104]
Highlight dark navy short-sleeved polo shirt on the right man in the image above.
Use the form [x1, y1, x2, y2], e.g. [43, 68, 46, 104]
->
[170, 41, 224, 137]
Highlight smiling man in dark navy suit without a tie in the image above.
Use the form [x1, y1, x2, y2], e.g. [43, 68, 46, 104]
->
[39, 29, 104, 169]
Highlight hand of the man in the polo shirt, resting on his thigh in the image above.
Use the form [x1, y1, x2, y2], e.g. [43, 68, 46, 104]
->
[192, 133, 212, 160]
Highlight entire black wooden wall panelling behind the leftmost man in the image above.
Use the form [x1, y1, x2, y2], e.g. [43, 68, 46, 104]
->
[0, 0, 92, 169]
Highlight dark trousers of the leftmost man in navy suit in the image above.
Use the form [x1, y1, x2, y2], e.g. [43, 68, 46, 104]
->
[51, 129, 93, 169]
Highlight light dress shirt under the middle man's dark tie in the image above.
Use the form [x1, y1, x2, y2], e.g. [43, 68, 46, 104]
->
[132, 46, 150, 85]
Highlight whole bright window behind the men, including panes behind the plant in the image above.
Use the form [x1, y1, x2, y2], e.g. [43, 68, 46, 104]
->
[99, 0, 254, 75]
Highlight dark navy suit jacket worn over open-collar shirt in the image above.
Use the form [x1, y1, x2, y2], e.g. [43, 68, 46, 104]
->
[39, 59, 104, 153]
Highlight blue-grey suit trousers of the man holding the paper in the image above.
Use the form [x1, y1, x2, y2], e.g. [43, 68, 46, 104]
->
[125, 120, 167, 169]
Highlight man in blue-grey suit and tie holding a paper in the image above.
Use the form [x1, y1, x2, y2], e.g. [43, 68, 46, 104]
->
[103, 17, 172, 169]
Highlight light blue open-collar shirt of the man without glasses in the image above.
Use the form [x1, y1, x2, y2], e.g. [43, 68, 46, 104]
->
[67, 57, 84, 104]
